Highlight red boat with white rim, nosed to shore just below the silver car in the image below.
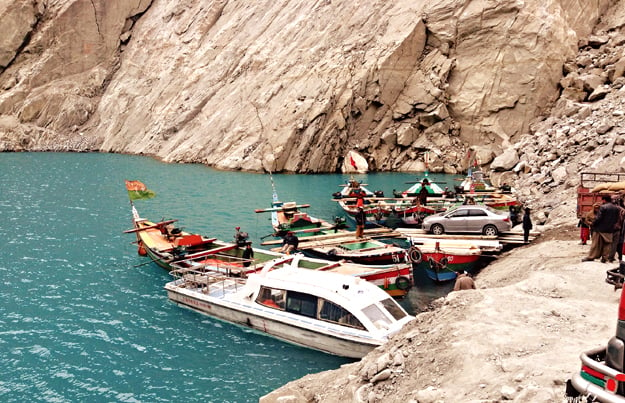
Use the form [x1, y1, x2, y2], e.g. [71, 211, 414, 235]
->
[408, 241, 482, 282]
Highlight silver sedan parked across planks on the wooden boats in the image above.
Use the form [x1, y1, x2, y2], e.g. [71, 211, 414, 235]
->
[423, 205, 512, 236]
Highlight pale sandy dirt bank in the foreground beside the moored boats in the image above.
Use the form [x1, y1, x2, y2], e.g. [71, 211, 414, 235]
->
[261, 225, 620, 403]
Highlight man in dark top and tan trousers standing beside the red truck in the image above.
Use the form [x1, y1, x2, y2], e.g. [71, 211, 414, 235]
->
[582, 195, 620, 263]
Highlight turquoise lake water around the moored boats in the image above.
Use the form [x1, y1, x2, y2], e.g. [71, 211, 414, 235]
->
[0, 153, 458, 402]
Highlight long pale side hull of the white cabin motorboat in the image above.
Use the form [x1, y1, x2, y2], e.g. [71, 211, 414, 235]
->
[167, 287, 381, 358]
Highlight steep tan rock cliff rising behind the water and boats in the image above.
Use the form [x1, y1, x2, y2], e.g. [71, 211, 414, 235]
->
[0, 0, 608, 173]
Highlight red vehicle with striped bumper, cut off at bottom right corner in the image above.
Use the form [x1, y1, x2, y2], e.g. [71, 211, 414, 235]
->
[566, 284, 625, 403]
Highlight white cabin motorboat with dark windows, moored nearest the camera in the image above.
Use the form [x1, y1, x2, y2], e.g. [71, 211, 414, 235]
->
[165, 256, 413, 358]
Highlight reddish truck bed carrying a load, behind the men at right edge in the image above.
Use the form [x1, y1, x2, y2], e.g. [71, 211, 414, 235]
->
[577, 172, 625, 218]
